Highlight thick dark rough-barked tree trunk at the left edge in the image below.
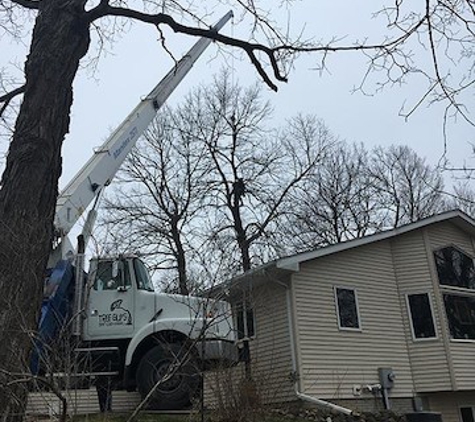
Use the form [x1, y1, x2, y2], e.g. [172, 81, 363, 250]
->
[0, 0, 89, 421]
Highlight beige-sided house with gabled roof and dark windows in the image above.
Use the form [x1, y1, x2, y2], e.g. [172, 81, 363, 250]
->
[206, 210, 475, 422]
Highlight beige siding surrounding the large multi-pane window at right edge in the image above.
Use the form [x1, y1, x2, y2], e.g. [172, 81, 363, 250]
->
[427, 223, 475, 390]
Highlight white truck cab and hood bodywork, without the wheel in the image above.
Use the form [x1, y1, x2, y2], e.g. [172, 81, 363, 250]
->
[83, 256, 234, 348]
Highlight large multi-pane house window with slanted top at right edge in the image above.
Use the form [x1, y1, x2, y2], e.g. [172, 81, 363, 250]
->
[434, 246, 475, 340]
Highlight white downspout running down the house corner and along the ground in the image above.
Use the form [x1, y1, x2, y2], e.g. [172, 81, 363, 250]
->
[275, 280, 358, 416]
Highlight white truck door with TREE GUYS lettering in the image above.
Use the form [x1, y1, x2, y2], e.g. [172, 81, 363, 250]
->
[87, 260, 135, 340]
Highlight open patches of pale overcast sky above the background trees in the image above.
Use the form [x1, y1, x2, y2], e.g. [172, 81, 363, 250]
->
[0, 0, 475, 190]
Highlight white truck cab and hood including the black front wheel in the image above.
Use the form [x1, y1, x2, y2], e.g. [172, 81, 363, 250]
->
[81, 256, 238, 408]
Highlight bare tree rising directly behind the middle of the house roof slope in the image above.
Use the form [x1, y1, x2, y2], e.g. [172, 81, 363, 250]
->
[286, 141, 379, 250]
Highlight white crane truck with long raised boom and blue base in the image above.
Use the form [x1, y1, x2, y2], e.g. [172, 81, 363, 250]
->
[31, 12, 236, 409]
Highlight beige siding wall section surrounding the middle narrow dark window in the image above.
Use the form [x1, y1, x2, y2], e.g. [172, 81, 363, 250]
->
[391, 230, 452, 392]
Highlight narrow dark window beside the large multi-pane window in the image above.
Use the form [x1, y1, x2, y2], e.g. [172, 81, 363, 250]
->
[407, 293, 436, 339]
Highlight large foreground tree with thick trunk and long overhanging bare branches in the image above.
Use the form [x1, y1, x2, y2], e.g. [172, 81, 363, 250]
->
[0, 0, 474, 420]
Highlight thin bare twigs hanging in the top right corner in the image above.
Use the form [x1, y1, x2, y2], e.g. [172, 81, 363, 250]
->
[350, 0, 475, 130]
